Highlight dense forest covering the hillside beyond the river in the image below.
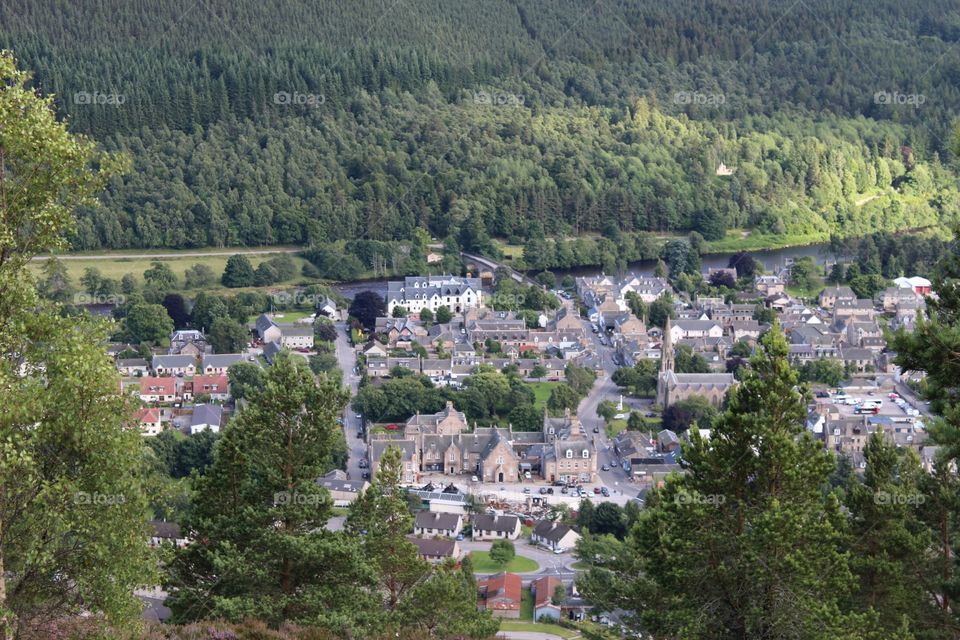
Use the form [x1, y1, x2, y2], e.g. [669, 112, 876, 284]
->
[0, 0, 960, 249]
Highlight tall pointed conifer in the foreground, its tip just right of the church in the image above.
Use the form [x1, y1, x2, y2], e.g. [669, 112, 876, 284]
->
[581, 326, 874, 640]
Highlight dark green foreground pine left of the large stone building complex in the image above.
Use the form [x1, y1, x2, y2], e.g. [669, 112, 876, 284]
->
[163, 352, 373, 634]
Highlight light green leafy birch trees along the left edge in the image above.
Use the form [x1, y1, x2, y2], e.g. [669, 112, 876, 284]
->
[0, 53, 153, 638]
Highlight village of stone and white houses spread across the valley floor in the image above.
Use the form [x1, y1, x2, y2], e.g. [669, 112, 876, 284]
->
[99, 256, 935, 624]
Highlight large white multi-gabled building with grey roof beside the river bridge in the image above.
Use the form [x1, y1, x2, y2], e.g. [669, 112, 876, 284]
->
[387, 275, 483, 315]
